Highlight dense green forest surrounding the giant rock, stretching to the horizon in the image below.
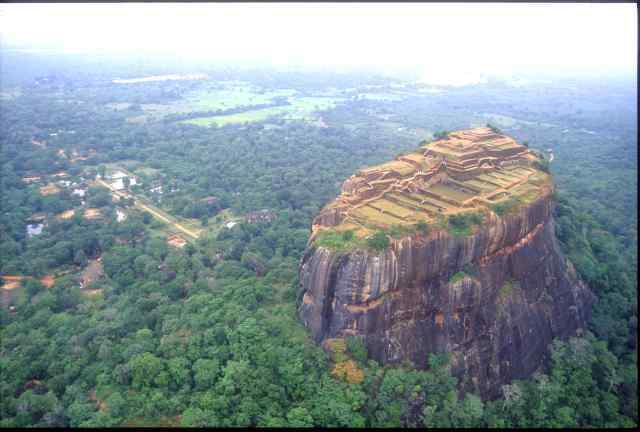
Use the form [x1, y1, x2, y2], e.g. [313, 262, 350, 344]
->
[0, 54, 638, 427]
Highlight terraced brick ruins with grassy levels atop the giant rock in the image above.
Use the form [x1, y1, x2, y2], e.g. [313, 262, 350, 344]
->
[313, 127, 546, 232]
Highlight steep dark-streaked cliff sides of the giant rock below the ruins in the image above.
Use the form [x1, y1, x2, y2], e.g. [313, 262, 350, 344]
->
[299, 188, 594, 398]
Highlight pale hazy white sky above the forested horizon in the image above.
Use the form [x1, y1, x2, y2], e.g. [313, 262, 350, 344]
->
[0, 3, 637, 79]
